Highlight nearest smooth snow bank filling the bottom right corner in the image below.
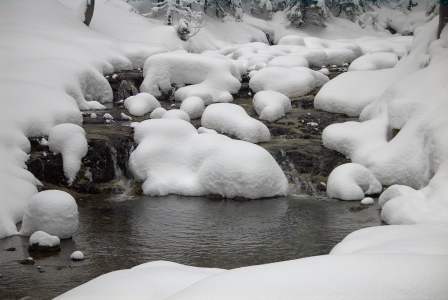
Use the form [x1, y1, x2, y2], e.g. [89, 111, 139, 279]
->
[167, 254, 448, 300]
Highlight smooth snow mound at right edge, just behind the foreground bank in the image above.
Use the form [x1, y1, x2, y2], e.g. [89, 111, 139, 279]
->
[331, 224, 448, 255]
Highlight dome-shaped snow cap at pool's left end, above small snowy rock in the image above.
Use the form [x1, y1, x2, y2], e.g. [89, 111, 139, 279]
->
[20, 190, 78, 239]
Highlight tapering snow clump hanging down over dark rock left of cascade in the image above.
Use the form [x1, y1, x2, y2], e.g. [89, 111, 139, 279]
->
[48, 124, 88, 185]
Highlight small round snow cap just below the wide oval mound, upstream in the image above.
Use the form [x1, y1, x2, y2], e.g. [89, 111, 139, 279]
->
[253, 91, 291, 122]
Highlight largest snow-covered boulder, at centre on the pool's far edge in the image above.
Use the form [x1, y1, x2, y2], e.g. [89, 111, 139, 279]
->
[129, 119, 288, 199]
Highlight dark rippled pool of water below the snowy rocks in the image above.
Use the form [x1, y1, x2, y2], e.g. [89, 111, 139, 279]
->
[0, 196, 380, 299]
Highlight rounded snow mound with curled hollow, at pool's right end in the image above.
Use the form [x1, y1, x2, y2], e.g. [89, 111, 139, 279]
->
[327, 163, 382, 200]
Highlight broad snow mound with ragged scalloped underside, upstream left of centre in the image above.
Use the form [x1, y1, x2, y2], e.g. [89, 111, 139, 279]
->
[140, 51, 241, 104]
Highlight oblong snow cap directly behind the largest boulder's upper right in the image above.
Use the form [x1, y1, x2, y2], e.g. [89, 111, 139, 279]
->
[201, 103, 271, 143]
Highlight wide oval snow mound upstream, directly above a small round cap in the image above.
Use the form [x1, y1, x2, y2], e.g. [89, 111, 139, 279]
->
[249, 67, 328, 98]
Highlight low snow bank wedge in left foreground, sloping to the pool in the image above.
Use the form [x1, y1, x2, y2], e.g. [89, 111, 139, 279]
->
[56, 261, 222, 300]
